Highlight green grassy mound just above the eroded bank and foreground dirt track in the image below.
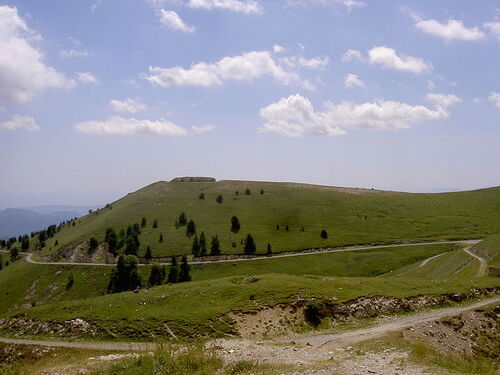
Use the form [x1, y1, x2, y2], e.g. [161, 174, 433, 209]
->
[6, 274, 499, 340]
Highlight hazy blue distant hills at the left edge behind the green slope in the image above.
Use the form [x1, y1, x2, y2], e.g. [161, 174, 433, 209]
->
[0, 205, 95, 238]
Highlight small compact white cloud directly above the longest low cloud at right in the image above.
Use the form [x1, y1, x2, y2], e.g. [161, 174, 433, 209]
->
[368, 46, 432, 74]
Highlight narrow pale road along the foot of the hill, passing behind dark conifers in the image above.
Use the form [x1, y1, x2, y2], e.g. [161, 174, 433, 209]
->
[3, 240, 480, 267]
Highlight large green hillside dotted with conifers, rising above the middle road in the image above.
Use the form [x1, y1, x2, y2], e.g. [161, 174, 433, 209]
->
[33, 181, 500, 256]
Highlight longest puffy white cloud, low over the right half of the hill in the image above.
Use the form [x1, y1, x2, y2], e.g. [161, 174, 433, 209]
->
[259, 94, 459, 137]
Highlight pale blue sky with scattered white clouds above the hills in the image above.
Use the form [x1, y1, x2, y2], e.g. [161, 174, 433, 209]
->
[0, 0, 500, 208]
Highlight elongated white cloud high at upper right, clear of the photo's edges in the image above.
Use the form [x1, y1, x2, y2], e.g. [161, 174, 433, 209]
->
[415, 19, 486, 41]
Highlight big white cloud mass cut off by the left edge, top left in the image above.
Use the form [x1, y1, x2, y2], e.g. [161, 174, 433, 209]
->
[0, 5, 72, 102]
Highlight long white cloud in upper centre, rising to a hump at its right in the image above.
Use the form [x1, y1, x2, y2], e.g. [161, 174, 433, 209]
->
[144, 51, 301, 87]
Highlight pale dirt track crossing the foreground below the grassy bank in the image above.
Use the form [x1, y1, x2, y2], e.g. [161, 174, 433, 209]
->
[0, 296, 500, 351]
